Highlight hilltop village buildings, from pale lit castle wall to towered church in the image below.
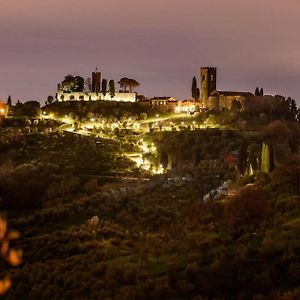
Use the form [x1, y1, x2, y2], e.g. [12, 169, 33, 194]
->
[55, 67, 284, 112]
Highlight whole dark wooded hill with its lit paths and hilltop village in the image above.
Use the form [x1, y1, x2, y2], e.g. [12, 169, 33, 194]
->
[0, 67, 300, 300]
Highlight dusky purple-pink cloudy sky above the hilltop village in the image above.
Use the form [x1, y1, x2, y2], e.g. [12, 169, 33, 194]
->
[0, 0, 300, 104]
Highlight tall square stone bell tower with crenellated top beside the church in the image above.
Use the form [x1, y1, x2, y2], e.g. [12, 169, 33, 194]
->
[200, 67, 217, 108]
